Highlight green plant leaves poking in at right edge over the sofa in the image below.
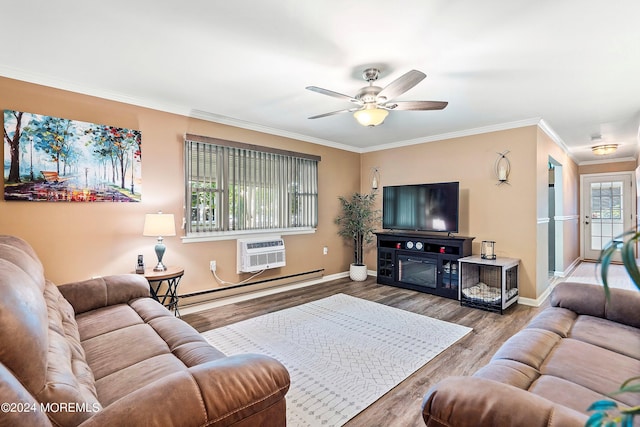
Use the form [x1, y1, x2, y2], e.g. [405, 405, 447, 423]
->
[586, 231, 640, 427]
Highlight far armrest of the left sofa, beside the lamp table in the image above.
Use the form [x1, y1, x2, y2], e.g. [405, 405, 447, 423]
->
[58, 274, 150, 314]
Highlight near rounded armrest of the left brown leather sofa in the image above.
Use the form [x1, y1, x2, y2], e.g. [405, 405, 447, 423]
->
[81, 354, 290, 427]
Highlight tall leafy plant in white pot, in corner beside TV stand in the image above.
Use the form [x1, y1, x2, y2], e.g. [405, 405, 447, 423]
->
[335, 193, 380, 281]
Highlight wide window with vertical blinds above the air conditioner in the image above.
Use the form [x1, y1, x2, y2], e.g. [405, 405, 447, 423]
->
[185, 134, 320, 237]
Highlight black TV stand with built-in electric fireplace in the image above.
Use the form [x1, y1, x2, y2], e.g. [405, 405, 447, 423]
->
[376, 231, 474, 300]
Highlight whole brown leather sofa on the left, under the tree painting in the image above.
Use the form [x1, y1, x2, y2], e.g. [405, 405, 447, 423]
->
[0, 236, 289, 427]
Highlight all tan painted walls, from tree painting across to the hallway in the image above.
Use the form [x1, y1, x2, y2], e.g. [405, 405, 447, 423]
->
[0, 78, 604, 298]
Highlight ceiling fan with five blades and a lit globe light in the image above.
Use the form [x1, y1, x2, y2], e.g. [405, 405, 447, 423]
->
[307, 68, 448, 126]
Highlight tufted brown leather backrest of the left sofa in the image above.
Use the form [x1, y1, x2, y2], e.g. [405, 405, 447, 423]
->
[0, 236, 102, 426]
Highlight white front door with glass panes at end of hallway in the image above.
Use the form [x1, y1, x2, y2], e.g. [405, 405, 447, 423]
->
[582, 172, 635, 260]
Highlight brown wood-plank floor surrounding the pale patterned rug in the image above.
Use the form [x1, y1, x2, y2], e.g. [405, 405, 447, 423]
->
[182, 278, 546, 427]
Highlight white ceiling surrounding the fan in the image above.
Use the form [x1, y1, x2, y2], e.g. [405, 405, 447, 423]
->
[0, 0, 640, 163]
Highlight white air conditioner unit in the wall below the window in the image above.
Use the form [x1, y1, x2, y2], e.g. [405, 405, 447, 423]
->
[237, 236, 286, 273]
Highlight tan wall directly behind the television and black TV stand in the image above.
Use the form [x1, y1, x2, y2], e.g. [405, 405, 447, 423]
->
[361, 126, 537, 298]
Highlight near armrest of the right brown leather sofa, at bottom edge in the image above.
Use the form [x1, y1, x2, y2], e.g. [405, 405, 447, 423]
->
[422, 377, 587, 427]
